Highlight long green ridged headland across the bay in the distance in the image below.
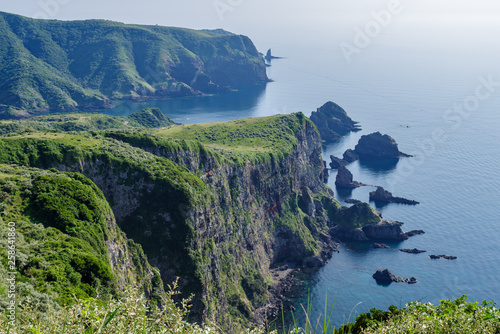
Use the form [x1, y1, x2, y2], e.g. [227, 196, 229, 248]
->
[0, 12, 268, 118]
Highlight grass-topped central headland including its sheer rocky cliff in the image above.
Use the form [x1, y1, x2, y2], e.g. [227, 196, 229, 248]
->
[0, 114, 339, 332]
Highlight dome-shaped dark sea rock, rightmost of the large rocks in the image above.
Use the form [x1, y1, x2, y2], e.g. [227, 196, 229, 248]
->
[354, 132, 410, 159]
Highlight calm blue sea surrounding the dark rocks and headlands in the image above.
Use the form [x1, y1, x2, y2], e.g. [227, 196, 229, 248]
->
[97, 19, 500, 325]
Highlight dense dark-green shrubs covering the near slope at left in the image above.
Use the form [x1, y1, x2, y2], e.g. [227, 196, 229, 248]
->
[0, 166, 158, 311]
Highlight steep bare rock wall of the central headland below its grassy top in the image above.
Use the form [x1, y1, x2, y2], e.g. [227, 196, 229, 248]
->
[33, 115, 339, 333]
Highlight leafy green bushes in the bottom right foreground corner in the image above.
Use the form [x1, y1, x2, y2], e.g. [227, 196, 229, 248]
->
[280, 295, 500, 334]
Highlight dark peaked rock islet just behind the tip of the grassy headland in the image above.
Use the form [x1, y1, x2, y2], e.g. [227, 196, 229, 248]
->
[310, 102, 360, 143]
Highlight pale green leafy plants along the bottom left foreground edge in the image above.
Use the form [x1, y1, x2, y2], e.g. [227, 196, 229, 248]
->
[0, 282, 257, 334]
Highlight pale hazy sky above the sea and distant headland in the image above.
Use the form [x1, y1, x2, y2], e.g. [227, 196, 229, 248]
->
[0, 0, 500, 49]
